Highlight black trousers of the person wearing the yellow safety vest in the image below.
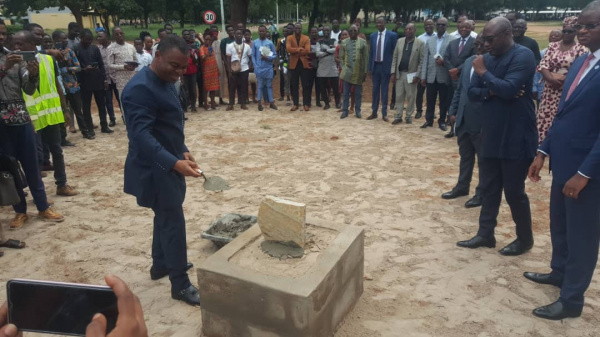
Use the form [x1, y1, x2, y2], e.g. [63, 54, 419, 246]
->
[37, 124, 67, 187]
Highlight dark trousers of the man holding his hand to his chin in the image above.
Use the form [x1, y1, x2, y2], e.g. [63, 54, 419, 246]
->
[477, 158, 533, 243]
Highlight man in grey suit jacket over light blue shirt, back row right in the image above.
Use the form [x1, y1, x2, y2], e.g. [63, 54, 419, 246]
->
[421, 17, 455, 131]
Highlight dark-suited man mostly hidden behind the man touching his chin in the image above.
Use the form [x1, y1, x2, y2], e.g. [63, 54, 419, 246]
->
[442, 37, 485, 208]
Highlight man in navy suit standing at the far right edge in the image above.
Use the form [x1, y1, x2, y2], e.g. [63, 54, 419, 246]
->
[524, 0, 600, 320]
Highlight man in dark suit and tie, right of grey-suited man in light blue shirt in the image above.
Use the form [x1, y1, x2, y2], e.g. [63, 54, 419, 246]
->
[444, 20, 475, 138]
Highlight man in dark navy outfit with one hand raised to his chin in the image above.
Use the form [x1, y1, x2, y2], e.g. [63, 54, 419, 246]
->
[457, 17, 538, 255]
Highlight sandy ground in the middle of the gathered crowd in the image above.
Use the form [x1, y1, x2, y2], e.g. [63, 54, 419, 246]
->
[0, 22, 600, 337]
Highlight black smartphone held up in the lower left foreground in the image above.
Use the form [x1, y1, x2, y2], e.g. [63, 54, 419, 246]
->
[6, 279, 119, 336]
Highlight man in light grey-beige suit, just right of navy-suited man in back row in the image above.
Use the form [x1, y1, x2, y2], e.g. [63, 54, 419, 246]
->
[391, 23, 425, 125]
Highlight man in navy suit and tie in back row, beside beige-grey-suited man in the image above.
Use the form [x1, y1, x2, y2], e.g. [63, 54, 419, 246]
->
[367, 17, 398, 122]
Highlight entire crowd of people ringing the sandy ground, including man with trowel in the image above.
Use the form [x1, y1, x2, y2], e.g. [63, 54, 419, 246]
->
[0, 0, 600, 330]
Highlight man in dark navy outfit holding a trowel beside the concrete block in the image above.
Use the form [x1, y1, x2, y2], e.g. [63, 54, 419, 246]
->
[122, 35, 201, 306]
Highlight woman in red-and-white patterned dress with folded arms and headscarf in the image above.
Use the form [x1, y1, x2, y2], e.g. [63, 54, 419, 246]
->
[537, 16, 587, 143]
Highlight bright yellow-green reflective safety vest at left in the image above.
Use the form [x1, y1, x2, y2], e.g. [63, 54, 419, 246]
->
[23, 54, 65, 131]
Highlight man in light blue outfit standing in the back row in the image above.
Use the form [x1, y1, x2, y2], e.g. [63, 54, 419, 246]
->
[252, 25, 277, 111]
